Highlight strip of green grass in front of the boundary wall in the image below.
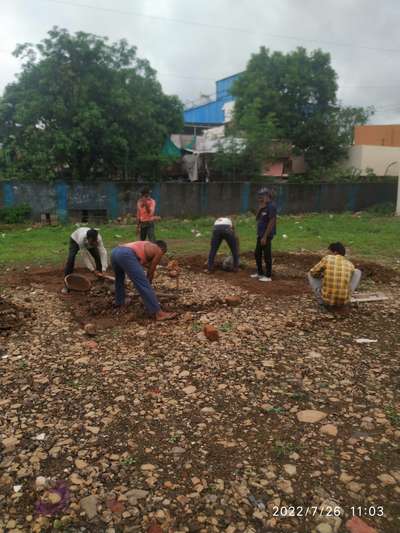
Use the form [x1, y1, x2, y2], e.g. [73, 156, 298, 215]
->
[0, 213, 400, 267]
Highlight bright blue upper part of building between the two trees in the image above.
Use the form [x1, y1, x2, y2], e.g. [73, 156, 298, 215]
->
[183, 74, 240, 134]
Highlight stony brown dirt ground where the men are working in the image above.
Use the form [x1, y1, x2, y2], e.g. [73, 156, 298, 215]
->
[0, 254, 400, 533]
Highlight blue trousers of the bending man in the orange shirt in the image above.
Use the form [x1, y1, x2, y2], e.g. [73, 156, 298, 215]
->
[111, 246, 161, 315]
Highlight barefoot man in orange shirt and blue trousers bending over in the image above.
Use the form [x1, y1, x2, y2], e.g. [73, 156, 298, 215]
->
[111, 241, 176, 321]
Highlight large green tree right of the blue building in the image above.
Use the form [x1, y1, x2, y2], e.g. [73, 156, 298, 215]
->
[232, 47, 372, 167]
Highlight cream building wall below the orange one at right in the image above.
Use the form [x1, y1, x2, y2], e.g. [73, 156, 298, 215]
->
[344, 145, 400, 176]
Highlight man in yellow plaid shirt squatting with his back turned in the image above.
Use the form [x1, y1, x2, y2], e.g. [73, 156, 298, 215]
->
[308, 242, 361, 307]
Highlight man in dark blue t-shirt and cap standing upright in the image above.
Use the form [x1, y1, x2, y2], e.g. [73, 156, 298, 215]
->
[251, 189, 276, 281]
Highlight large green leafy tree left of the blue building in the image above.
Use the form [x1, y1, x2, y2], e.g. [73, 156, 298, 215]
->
[0, 28, 182, 179]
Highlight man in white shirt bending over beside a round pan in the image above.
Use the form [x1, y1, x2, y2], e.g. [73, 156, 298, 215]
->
[64, 228, 107, 276]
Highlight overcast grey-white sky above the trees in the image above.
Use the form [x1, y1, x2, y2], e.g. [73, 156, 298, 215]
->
[0, 0, 400, 124]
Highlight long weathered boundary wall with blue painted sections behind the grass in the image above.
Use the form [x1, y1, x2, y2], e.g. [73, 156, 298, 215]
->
[0, 181, 397, 222]
